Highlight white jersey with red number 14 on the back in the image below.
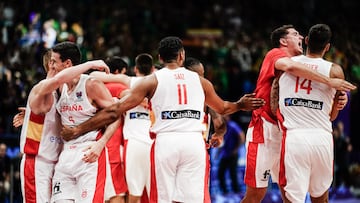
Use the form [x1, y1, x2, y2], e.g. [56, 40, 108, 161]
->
[279, 55, 336, 132]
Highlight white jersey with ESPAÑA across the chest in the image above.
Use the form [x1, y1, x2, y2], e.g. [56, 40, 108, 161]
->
[56, 74, 97, 143]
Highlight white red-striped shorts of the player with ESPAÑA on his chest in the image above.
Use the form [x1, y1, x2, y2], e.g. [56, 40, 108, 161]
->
[51, 142, 106, 202]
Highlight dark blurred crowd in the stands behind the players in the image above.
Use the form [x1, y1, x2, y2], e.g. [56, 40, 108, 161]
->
[0, 0, 360, 201]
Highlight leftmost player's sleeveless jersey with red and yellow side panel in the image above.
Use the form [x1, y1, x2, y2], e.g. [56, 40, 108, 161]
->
[20, 92, 63, 161]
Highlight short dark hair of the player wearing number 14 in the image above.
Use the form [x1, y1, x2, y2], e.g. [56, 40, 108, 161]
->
[308, 24, 331, 53]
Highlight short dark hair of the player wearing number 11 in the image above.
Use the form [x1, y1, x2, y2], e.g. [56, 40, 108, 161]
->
[158, 36, 184, 63]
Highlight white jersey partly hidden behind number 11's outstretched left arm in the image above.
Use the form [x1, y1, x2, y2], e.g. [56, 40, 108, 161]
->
[123, 77, 153, 144]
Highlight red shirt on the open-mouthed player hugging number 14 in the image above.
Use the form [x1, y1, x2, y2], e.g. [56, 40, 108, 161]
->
[249, 48, 287, 143]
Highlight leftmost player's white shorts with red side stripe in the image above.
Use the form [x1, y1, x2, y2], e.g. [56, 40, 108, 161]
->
[20, 154, 55, 202]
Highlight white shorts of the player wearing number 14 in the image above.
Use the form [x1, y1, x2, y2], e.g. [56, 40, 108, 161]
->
[280, 129, 334, 202]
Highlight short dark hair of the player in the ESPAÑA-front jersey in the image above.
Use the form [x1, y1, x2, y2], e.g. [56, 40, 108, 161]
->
[52, 41, 81, 66]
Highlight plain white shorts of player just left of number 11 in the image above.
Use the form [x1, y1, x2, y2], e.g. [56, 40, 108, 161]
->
[125, 138, 151, 196]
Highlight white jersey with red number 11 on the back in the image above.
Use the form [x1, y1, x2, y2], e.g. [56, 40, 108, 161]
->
[151, 67, 205, 134]
